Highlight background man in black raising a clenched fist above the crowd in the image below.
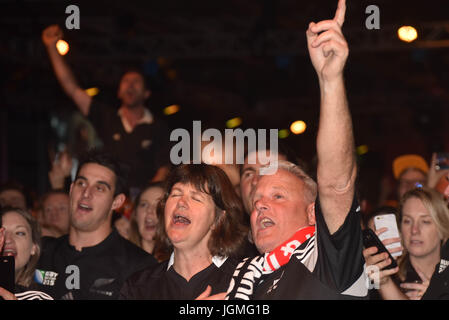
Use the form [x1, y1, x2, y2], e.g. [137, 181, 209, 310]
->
[42, 25, 170, 188]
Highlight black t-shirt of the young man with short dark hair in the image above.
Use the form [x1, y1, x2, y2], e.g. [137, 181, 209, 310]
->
[35, 229, 157, 300]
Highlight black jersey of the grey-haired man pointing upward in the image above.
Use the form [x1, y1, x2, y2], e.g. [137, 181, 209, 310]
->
[229, 195, 368, 300]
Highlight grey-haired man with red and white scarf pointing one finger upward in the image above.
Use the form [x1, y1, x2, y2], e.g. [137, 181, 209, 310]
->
[227, 0, 368, 300]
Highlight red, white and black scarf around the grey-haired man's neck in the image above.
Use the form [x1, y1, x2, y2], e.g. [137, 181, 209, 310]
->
[226, 226, 316, 300]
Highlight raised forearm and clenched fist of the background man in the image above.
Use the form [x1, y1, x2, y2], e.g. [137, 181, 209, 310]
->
[42, 25, 92, 116]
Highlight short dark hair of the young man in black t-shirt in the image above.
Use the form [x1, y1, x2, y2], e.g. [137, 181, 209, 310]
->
[76, 148, 130, 197]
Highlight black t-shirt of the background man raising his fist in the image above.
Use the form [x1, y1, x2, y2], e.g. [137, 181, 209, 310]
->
[88, 100, 170, 188]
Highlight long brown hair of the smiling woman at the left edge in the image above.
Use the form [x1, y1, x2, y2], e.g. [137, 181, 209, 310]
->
[0, 207, 41, 287]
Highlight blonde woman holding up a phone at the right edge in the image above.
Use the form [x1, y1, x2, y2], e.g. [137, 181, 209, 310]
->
[363, 188, 449, 300]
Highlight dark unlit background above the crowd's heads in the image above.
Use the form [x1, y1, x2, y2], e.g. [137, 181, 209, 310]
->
[0, 0, 449, 205]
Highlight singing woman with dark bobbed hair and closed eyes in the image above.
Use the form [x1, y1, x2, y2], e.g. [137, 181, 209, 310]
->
[121, 164, 247, 300]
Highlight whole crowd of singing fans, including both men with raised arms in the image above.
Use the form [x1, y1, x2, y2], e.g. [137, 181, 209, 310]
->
[0, 0, 449, 300]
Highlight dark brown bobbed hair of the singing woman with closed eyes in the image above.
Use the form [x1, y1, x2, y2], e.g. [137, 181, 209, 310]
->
[156, 163, 248, 257]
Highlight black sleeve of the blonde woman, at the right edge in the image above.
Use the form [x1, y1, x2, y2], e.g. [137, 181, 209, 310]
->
[422, 241, 449, 300]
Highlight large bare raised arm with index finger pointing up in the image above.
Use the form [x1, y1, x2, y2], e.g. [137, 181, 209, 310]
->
[306, 0, 357, 234]
